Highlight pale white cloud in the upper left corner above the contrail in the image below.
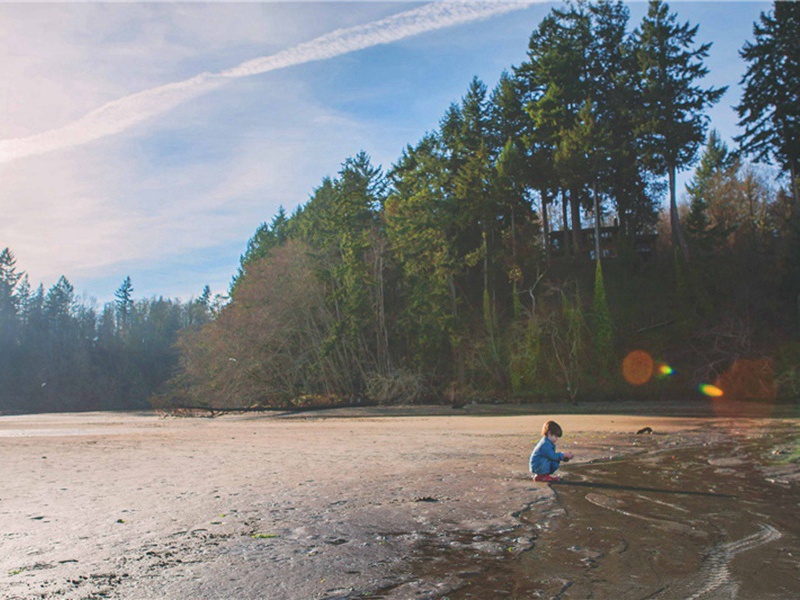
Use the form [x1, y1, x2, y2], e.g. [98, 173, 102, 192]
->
[0, 2, 372, 138]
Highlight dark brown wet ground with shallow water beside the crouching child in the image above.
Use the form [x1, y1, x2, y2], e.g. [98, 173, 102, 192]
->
[424, 427, 800, 600]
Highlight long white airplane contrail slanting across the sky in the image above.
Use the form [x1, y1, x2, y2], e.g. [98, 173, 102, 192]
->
[0, 0, 542, 164]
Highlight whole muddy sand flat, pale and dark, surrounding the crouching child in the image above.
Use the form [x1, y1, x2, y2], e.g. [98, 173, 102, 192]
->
[0, 406, 800, 599]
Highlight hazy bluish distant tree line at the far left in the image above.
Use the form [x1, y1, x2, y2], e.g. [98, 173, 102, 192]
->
[0, 248, 214, 414]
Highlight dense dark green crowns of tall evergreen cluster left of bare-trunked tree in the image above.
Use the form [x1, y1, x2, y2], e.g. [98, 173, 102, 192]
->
[516, 2, 660, 252]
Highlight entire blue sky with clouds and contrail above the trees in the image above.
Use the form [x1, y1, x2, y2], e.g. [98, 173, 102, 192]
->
[0, 1, 771, 304]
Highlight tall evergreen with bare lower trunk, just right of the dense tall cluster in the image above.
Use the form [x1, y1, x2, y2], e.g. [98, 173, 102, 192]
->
[635, 0, 727, 258]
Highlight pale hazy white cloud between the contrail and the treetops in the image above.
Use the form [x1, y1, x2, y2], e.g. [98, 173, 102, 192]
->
[0, 90, 367, 287]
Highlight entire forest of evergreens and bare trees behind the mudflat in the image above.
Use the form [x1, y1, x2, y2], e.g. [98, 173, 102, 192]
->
[0, 0, 800, 412]
